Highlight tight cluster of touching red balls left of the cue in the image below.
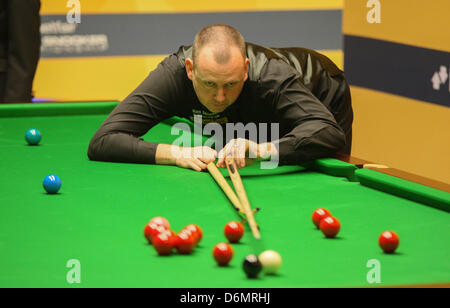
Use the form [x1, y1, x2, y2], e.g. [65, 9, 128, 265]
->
[144, 217, 203, 256]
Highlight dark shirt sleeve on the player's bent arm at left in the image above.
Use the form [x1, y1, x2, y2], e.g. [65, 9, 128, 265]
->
[88, 55, 183, 164]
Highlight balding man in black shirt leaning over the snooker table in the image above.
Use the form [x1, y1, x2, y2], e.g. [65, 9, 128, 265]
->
[88, 25, 353, 171]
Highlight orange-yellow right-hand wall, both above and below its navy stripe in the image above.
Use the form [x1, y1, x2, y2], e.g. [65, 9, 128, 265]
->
[344, 0, 450, 183]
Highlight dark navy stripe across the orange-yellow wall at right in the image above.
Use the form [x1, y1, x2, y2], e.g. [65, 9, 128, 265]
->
[344, 35, 450, 107]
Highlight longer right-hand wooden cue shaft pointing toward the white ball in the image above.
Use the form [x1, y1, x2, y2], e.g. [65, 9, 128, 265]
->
[225, 157, 261, 239]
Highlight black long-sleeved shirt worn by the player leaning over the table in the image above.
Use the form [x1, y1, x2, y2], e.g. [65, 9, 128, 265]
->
[88, 43, 353, 165]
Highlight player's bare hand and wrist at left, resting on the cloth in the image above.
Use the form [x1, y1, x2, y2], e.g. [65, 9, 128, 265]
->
[155, 144, 217, 171]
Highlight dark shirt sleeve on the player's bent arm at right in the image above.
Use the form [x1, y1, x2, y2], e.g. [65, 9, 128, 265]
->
[268, 61, 346, 165]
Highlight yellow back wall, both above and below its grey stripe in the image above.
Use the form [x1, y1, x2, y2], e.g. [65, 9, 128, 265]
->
[34, 0, 343, 100]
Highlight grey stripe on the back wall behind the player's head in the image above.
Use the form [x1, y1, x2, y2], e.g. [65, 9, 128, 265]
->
[42, 10, 342, 58]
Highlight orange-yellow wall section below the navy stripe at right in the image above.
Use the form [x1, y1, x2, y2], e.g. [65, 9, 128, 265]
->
[351, 87, 450, 183]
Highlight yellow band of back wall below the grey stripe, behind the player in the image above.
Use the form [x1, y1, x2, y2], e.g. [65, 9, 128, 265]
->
[34, 50, 343, 100]
